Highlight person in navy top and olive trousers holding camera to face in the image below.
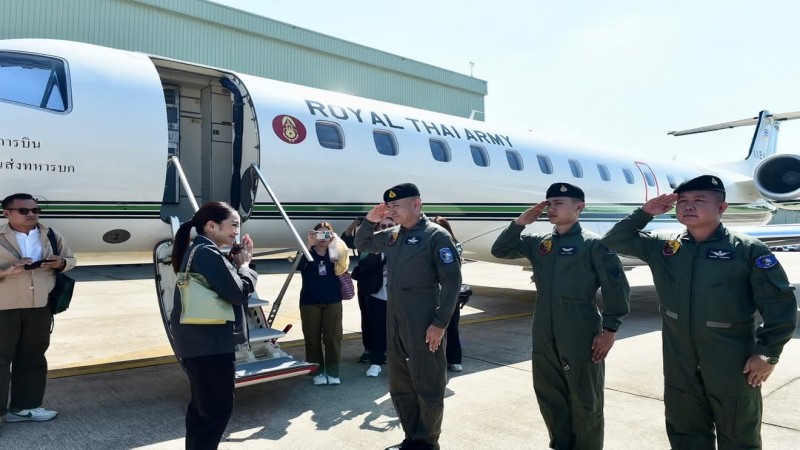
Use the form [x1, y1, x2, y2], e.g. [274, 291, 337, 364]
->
[298, 222, 350, 386]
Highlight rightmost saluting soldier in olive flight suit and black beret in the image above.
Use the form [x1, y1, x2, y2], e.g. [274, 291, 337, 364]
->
[603, 175, 797, 450]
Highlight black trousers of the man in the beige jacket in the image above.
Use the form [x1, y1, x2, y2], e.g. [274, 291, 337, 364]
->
[0, 306, 53, 416]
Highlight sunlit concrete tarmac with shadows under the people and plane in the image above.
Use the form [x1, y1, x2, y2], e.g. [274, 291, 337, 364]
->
[0, 252, 800, 450]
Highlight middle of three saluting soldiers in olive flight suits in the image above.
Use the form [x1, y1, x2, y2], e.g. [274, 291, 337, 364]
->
[492, 183, 630, 450]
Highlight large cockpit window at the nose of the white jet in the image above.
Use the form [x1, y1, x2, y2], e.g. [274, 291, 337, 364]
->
[0, 52, 70, 112]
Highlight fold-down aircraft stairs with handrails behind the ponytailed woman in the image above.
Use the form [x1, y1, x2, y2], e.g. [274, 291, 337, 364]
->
[153, 157, 318, 387]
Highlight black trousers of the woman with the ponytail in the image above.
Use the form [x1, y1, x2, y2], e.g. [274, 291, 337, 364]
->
[181, 353, 235, 450]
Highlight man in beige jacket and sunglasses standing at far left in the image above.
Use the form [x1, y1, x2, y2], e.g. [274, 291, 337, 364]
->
[0, 194, 75, 426]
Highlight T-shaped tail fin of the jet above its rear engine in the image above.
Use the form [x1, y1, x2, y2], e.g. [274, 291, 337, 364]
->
[667, 110, 800, 169]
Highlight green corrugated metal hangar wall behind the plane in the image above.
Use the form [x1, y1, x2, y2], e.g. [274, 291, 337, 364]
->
[0, 0, 487, 119]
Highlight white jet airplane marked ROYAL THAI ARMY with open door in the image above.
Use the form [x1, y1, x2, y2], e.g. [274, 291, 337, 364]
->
[0, 39, 800, 385]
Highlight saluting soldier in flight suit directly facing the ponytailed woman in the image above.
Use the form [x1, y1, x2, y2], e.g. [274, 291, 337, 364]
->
[355, 183, 461, 450]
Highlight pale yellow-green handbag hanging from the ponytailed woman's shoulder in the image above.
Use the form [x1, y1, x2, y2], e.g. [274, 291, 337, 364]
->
[177, 246, 235, 325]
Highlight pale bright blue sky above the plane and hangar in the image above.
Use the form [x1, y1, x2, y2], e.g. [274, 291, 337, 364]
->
[215, 0, 800, 164]
